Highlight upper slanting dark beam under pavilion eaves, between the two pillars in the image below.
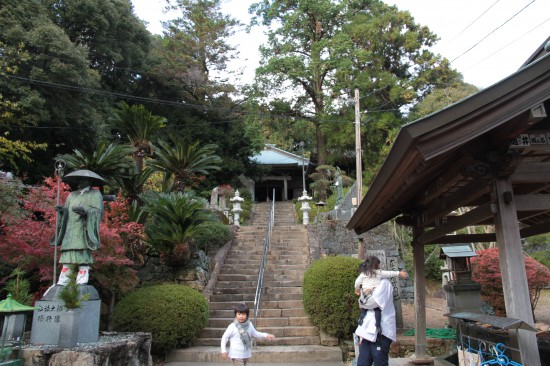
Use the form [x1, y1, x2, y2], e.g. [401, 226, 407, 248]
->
[419, 179, 489, 227]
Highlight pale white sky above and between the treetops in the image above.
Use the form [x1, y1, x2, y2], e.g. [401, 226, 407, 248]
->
[132, 0, 550, 88]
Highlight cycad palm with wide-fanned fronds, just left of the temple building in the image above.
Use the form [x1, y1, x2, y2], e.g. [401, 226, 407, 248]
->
[149, 138, 222, 192]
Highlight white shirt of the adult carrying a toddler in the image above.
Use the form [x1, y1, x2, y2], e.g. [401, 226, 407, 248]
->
[355, 279, 397, 342]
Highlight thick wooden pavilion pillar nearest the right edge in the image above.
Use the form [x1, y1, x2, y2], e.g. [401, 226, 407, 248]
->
[493, 177, 540, 366]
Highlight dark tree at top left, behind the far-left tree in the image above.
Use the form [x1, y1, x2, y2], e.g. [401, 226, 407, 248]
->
[43, 0, 151, 93]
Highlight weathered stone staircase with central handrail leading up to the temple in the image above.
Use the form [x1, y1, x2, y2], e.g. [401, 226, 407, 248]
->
[166, 202, 342, 366]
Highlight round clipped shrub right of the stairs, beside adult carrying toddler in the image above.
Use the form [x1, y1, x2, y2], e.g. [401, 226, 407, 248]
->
[303, 256, 361, 339]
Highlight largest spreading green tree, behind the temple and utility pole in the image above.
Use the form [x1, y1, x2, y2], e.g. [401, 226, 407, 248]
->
[250, 0, 457, 164]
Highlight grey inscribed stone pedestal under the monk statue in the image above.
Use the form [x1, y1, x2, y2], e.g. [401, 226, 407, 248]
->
[30, 285, 101, 345]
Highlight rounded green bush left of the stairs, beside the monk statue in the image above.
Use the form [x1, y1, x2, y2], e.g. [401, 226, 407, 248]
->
[113, 284, 208, 355]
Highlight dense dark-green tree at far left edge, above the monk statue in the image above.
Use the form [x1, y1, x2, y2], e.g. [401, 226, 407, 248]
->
[0, 0, 119, 181]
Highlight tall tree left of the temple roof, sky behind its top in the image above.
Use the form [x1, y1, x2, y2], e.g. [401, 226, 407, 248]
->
[143, 0, 263, 186]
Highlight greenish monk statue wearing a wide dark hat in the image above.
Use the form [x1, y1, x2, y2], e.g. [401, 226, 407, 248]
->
[52, 170, 106, 286]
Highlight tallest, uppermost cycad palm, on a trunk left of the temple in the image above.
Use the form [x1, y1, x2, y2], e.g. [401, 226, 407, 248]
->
[109, 102, 166, 171]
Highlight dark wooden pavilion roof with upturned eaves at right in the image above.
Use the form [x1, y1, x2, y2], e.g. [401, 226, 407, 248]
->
[347, 49, 550, 244]
